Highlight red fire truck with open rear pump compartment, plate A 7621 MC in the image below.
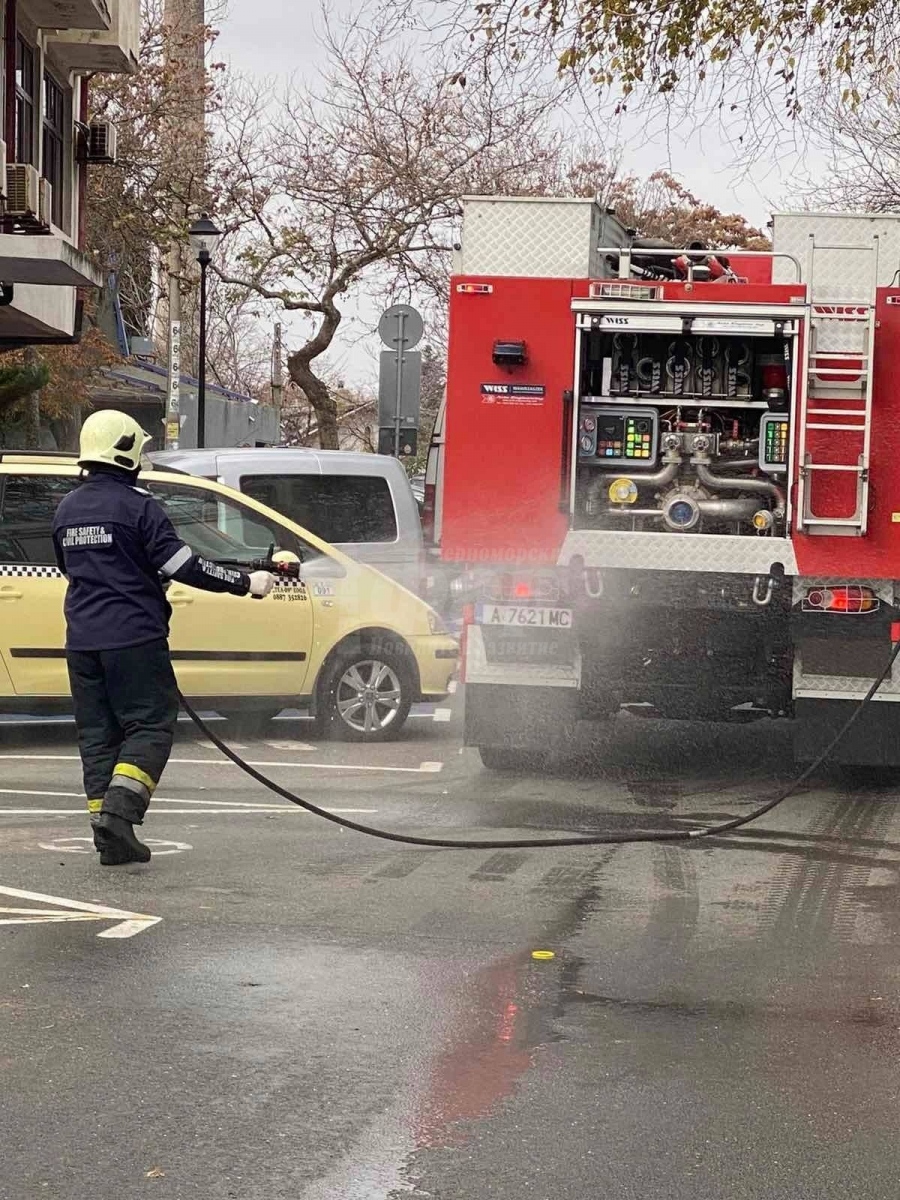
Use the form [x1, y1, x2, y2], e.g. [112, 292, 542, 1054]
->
[426, 197, 900, 768]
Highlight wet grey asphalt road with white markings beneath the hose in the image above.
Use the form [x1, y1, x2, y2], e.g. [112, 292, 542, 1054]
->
[0, 704, 900, 1200]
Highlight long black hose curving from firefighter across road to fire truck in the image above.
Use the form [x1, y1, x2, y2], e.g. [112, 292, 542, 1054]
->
[181, 641, 900, 850]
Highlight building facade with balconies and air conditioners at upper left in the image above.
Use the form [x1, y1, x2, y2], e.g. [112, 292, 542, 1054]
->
[0, 0, 140, 350]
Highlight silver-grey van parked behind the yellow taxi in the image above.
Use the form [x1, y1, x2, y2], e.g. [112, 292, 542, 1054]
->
[149, 446, 425, 595]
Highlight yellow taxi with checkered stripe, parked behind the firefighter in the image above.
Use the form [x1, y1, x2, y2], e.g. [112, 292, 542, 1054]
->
[0, 452, 457, 742]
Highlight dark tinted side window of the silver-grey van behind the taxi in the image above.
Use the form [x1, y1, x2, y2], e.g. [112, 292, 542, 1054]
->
[240, 475, 397, 545]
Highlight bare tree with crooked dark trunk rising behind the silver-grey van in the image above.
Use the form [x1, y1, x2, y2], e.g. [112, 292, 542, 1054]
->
[214, 10, 556, 448]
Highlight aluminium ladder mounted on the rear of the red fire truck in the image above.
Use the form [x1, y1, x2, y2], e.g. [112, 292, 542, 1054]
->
[797, 234, 878, 538]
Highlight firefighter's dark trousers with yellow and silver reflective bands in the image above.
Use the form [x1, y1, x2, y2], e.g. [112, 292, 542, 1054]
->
[66, 638, 179, 826]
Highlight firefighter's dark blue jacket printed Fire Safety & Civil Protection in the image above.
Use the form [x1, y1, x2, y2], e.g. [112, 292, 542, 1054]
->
[53, 473, 250, 650]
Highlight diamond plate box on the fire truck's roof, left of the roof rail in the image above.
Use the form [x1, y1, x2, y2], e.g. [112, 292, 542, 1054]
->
[456, 197, 626, 278]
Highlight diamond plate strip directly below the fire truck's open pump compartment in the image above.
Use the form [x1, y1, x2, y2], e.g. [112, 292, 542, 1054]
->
[558, 529, 797, 575]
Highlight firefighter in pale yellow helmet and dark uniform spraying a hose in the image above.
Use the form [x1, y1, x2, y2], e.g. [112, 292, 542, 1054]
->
[53, 410, 275, 866]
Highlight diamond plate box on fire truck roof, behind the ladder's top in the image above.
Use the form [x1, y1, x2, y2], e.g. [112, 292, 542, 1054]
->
[772, 212, 900, 298]
